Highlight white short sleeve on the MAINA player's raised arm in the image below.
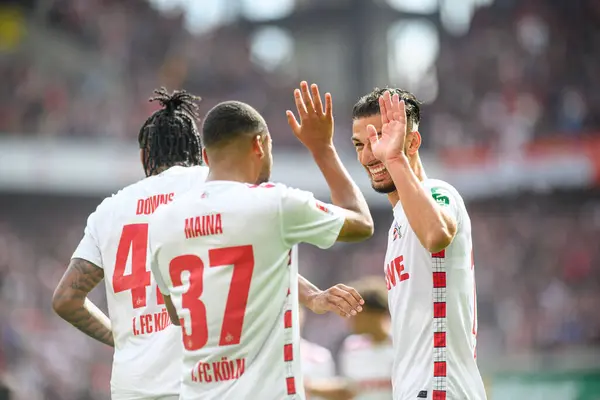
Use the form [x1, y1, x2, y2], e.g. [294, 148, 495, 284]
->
[281, 187, 345, 249]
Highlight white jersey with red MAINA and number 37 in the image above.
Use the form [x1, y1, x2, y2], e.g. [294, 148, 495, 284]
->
[150, 181, 344, 400]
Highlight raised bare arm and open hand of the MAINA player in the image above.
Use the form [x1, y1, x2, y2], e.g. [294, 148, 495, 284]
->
[287, 82, 374, 242]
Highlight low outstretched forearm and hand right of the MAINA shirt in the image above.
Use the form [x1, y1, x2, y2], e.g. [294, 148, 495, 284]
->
[298, 275, 365, 317]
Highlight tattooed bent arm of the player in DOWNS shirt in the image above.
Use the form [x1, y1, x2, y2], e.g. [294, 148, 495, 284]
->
[52, 258, 115, 347]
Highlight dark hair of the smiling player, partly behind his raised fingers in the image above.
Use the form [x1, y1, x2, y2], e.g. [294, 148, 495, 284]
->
[352, 87, 422, 130]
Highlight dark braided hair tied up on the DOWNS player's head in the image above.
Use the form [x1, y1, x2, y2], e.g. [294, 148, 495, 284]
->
[138, 87, 202, 176]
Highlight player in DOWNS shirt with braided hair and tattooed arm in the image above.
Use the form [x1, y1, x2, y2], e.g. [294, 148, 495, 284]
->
[53, 88, 208, 400]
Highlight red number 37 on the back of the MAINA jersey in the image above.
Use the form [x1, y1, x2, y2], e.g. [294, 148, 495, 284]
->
[169, 245, 254, 351]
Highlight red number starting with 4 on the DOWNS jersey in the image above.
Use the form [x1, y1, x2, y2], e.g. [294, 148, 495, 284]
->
[112, 224, 165, 308]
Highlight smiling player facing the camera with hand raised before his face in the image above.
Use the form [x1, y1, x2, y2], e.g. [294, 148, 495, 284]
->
[352, 89, 486, 400]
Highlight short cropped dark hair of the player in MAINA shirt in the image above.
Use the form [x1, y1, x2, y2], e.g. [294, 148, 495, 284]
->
[202, 101, 268, 148]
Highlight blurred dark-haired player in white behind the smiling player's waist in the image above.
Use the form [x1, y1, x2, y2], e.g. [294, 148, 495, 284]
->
[339, 277, 394, 400]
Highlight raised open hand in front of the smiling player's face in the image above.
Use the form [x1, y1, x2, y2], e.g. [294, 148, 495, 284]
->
[367, 92, 406, 164]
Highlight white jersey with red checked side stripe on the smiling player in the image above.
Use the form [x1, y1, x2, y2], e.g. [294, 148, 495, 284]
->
[385, 179, 486, 400]
